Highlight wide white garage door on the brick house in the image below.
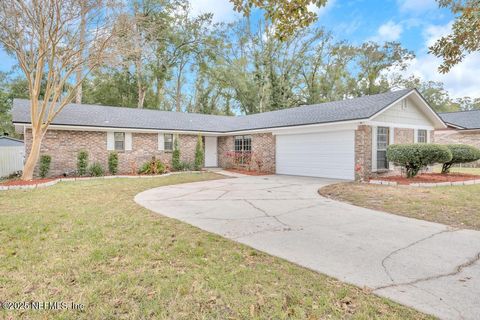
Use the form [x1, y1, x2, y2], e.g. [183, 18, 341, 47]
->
[276, 130, 355, 180]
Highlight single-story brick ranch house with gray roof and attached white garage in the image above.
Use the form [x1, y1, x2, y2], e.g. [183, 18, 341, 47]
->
[13, 89, 446, 180]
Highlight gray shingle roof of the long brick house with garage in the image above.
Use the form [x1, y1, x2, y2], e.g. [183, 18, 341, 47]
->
[12, 89, 413, 132]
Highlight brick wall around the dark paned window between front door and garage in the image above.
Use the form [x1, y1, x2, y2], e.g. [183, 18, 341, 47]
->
[218, 133, 275, 173]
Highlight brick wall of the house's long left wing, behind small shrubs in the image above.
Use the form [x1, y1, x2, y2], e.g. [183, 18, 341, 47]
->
[25, 130, 197, 176]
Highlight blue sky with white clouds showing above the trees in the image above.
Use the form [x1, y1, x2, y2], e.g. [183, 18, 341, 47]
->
[0, 0, 480, 97]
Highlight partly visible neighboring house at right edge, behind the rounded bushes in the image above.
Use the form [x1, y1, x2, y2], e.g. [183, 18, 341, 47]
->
[435, 110, 480, 165]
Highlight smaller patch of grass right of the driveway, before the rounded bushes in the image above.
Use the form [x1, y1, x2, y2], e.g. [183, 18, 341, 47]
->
[319, 183, 480, 230]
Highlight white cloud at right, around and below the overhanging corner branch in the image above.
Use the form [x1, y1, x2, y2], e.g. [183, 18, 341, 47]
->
[405, 22, 480, 98]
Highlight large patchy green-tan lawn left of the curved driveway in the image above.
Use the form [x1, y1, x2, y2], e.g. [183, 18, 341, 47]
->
[0, 173, 428, 319]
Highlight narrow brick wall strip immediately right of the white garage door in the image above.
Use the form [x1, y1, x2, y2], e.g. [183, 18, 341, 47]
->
[355, 125, 372, 179]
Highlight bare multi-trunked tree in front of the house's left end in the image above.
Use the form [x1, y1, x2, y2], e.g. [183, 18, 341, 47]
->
[0, 0, 114, 180]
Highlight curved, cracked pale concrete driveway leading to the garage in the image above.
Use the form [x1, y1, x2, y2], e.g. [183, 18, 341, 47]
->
[135, 176, 480, 319]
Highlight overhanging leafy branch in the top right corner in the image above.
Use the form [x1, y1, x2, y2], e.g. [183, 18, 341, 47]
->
[430, 0, 480, 73]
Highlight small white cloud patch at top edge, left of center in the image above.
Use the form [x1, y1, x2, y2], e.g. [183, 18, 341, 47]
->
[190, 0, 241, 22]
